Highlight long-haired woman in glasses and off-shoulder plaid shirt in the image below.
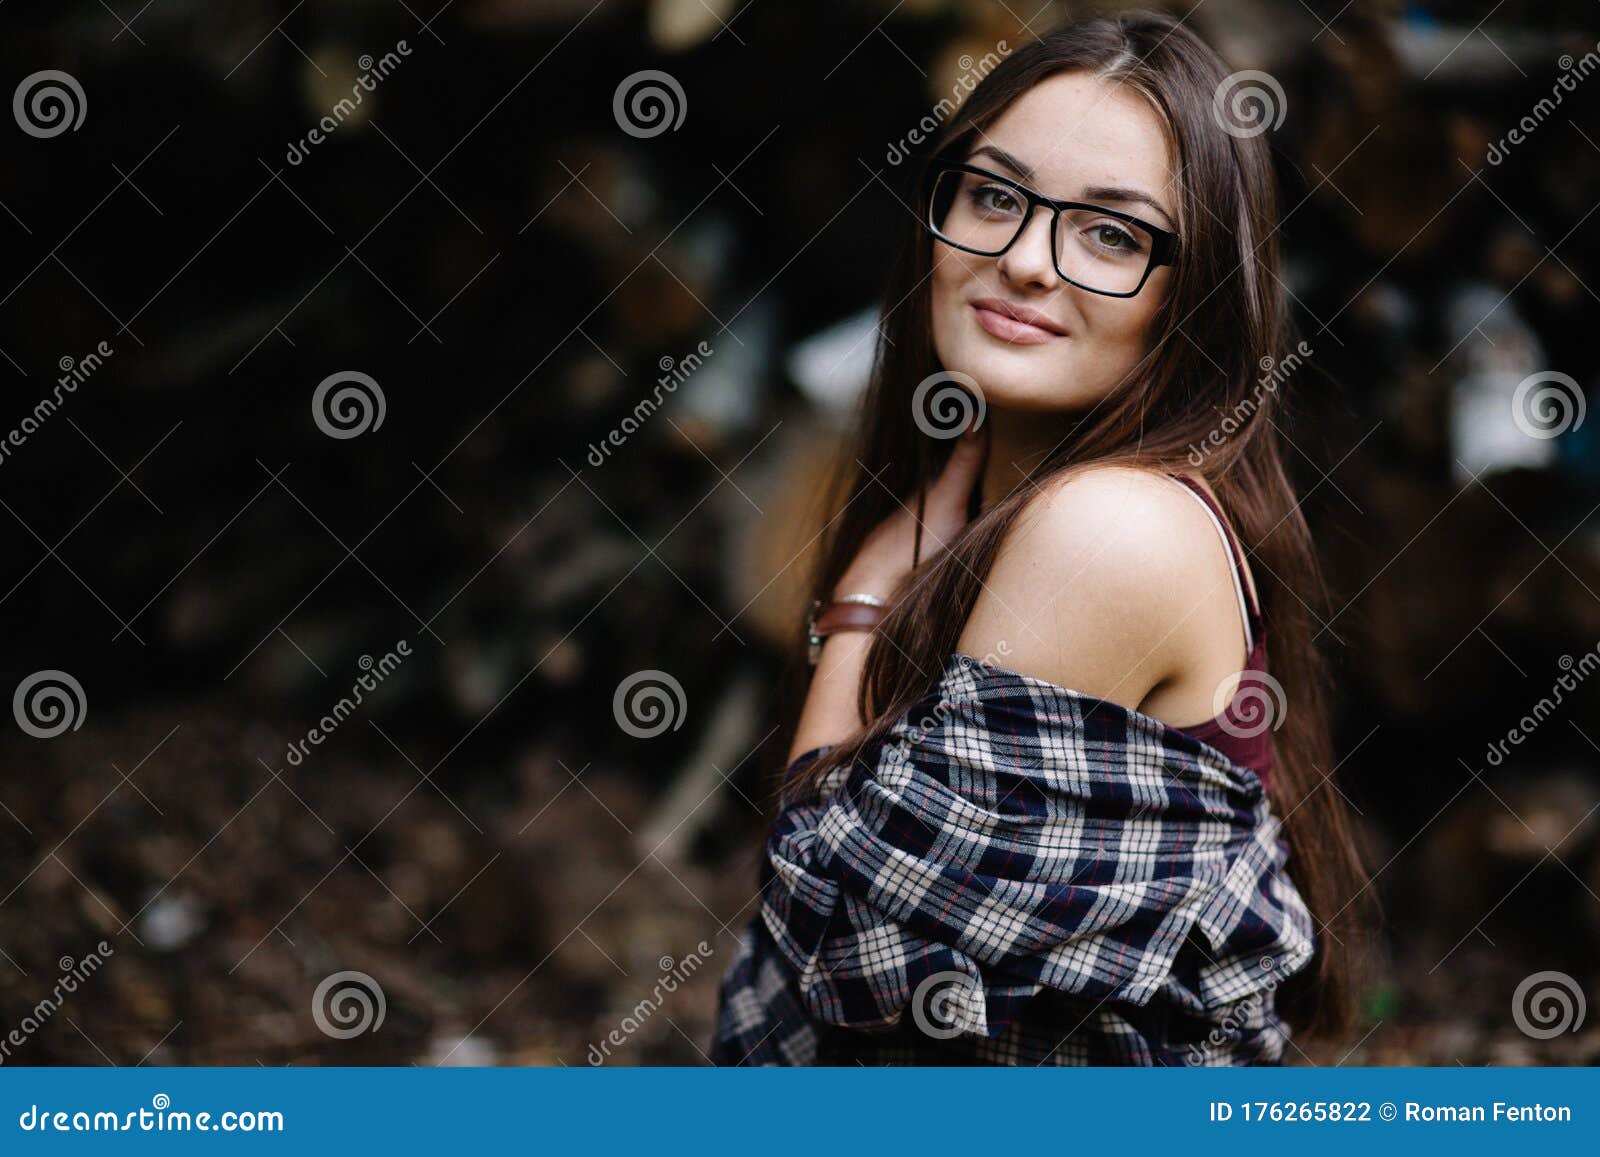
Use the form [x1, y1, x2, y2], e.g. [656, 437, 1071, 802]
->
[714, 14, 1366, 1064]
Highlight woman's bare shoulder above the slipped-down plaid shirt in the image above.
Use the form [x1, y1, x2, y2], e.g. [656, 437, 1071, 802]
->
[957, 466, 1240, 707]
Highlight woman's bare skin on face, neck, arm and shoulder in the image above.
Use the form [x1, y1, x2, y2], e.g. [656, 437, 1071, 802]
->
[789, 74, 1254, 760]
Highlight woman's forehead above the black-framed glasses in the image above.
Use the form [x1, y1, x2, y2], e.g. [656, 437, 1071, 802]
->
[973, 72, 1173, 208]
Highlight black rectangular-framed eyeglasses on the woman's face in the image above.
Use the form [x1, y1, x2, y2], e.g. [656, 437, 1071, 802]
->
[923, 160, 1178, 298]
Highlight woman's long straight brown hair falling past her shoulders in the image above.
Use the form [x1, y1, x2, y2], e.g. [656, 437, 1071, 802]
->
[789, 13, 1370, 1039]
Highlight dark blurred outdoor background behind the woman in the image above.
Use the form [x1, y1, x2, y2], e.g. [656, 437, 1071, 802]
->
[0, 0, 1600, 1064]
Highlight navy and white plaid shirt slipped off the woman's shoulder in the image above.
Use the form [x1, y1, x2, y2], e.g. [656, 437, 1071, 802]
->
[712, 655, 1314, 1064]
